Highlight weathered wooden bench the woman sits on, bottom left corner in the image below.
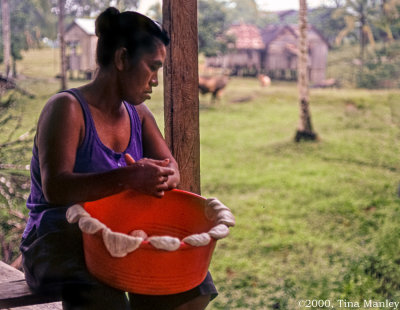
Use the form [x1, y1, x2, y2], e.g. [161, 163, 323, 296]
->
[0, 261, 62, 310]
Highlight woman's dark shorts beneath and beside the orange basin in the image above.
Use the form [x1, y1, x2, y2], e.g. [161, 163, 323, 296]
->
[20, 212, 218, 310]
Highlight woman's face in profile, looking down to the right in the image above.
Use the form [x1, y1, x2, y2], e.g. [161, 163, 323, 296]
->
[121, 43, 166, 105]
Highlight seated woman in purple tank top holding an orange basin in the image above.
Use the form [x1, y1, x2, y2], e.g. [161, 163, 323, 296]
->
[21, 8, 217, 310]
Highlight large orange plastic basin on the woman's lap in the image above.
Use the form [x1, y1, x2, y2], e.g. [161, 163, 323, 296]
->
[83, 190, 216, 295]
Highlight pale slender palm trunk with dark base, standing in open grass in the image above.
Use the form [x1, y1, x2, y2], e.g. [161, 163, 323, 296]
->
[295, 0, 318, 142]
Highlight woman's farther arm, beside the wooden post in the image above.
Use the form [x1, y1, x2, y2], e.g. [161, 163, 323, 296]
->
[136, 103, 180, 189]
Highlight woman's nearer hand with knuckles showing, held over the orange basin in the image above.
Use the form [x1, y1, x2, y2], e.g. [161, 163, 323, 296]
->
[125, 154, 176, 198]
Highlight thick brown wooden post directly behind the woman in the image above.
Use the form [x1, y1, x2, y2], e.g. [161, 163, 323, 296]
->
[163, 0, 200, 194]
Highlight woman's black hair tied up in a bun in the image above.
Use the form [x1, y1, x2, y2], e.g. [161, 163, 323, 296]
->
[96, 7, 169, 66]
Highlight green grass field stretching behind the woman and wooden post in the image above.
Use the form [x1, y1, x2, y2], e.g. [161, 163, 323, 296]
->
[0, 50, 400, 310]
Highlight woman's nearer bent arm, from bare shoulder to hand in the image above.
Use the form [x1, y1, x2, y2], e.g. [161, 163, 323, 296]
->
[36, 93, 175, 204]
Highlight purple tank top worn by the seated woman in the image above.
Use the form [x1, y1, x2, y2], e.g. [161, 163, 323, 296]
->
[22, 89, 143, 238]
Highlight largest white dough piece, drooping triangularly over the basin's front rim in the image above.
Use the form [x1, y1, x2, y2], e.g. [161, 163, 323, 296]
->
[103, 228, 143, 257]
